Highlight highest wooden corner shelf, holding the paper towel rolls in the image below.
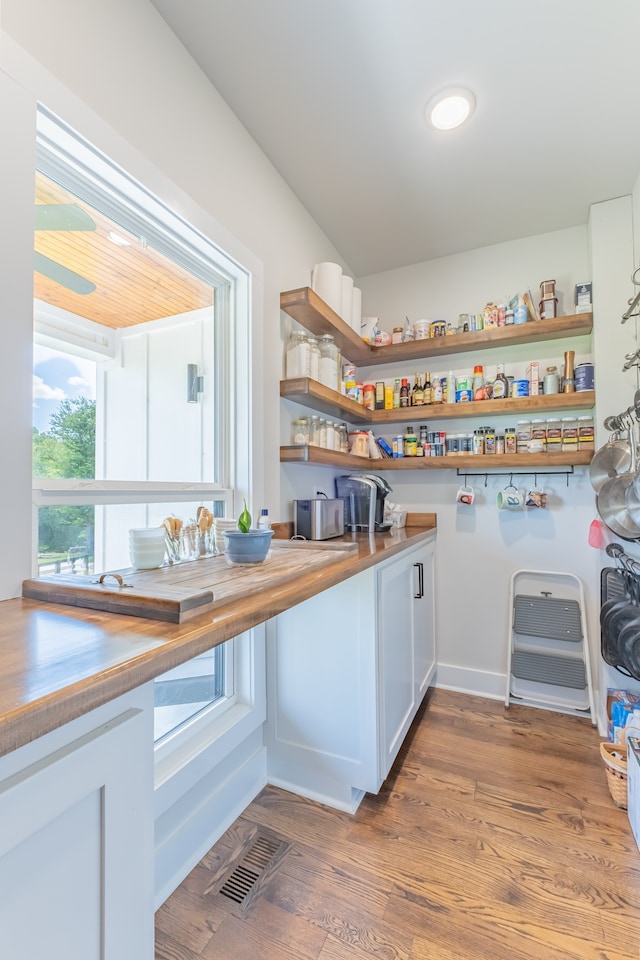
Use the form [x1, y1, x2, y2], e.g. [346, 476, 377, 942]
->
[280, 287, 593, 366]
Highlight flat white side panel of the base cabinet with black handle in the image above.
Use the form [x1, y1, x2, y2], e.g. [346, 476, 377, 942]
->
[266, 569, 379, 811]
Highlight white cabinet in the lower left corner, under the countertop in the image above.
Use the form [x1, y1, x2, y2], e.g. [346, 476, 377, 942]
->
[0, 685, 153, 960]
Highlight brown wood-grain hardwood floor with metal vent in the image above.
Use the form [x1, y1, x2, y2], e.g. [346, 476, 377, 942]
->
[156, 690, 640, 960]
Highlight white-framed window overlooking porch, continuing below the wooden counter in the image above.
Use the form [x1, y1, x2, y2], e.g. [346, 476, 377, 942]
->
[33, 111, 249, 740]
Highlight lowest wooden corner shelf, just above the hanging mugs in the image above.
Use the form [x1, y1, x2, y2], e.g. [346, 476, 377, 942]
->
[280, 446, 593, 473]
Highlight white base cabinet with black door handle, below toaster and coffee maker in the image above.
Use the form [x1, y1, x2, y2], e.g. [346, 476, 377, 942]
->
[266, 535, 435, 811]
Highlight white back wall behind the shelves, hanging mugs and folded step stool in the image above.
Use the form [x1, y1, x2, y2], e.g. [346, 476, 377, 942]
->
[358, 227, 608, 712]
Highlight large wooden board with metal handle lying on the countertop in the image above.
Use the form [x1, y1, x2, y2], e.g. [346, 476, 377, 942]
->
[22, 540, 358, 623]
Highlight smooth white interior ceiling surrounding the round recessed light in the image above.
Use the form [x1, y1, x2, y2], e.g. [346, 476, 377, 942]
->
[152, 0, 640, 276]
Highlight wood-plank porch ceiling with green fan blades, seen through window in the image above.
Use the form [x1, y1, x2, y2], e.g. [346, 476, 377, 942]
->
[34, 173, 213, 328]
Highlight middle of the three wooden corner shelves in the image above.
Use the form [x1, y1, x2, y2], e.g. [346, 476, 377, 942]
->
[280, 376, 595, 425]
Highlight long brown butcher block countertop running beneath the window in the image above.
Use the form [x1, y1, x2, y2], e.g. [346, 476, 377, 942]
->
[0, 514, 436, 755]
